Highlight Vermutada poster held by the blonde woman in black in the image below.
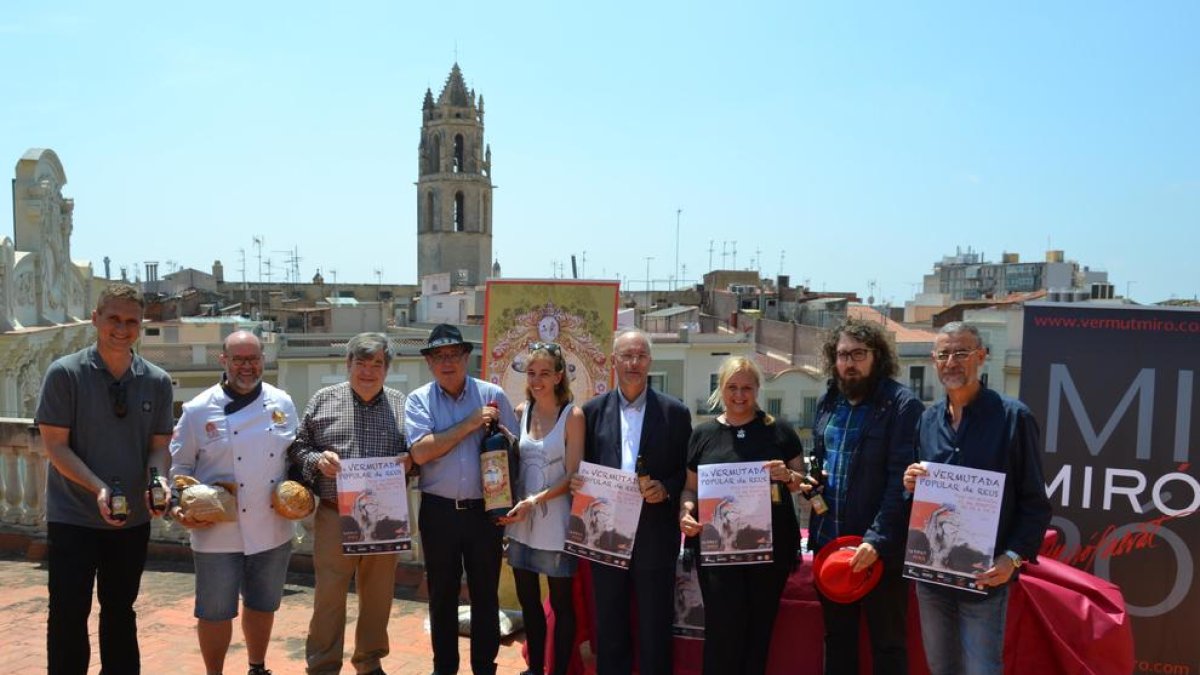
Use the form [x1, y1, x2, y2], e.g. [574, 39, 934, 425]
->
[696, 461, 774, 565]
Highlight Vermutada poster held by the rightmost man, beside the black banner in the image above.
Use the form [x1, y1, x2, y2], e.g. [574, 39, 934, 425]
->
[904, 461, 1004, 593]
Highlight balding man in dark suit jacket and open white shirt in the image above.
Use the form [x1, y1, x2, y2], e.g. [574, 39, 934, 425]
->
[583, 330, 691, 675]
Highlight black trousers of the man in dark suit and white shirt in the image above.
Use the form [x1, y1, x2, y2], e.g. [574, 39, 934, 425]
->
[592, 562, 674, 675]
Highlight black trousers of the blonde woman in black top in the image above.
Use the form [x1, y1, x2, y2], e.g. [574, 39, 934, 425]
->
[700, 562, 791, 675]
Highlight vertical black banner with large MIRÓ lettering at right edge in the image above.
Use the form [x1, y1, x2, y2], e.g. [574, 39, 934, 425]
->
[1021, 304, 1200, 673]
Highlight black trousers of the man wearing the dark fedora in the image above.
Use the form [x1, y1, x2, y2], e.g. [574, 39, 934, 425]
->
[418, 495, 504, 675]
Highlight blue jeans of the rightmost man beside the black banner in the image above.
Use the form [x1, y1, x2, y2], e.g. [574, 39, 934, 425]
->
[917, 583, 1008, 675]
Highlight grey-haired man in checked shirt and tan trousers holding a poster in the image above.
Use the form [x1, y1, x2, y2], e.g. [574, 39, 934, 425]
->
[288, 333, 409, 675]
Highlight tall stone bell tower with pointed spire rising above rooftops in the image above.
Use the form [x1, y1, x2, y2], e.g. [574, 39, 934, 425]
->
[416, 64, 493, 287]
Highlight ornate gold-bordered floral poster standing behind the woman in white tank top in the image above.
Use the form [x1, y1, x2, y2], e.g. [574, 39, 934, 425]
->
[484, 279, 619, 405]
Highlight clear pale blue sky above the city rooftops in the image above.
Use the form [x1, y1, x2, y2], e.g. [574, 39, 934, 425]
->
[0, 1, 1200, 304]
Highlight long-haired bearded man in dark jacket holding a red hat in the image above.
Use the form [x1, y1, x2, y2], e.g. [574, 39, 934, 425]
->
[800, 319, 923, 675]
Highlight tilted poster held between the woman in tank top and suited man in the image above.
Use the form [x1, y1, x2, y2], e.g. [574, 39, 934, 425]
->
[564, 461, 642, 568]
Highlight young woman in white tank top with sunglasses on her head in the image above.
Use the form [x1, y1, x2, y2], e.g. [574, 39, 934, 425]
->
[505, 342, 584, 675]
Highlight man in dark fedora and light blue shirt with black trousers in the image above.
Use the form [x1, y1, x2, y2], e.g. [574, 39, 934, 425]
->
[404, 323, 517, 675]
